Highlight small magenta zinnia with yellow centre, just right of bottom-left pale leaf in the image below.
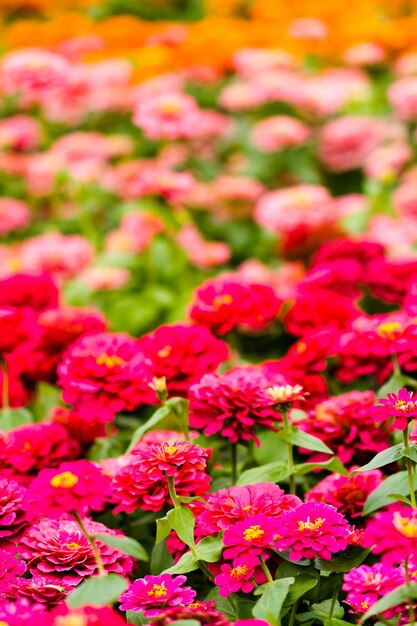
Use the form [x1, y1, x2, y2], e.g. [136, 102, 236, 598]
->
[120, 574, 196, 617]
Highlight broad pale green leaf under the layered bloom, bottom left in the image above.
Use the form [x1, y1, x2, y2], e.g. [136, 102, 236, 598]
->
[66, 574, 129, 609]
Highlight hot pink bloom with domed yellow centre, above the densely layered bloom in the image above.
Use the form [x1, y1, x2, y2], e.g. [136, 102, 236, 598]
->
[26, 459, 111, 518]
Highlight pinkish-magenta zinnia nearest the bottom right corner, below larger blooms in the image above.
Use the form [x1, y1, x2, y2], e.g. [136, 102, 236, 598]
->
[342, 563, 405, 619]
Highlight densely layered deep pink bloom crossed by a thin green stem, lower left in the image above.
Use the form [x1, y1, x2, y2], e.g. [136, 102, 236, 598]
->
[19, 518, 133, 587]
